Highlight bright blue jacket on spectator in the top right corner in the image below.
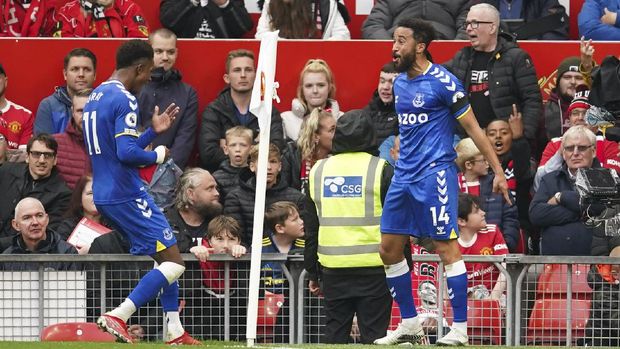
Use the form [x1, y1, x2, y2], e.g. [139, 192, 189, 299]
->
[577, 0, 620, 41]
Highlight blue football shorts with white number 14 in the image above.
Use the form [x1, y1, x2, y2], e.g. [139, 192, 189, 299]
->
[381, 166, 459, 240]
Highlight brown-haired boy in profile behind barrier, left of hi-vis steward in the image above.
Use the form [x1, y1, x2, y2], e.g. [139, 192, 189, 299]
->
[261, 201, 305, 343]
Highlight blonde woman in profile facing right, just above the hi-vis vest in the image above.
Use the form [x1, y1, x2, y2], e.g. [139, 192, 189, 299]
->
[282, 107, 336, 193]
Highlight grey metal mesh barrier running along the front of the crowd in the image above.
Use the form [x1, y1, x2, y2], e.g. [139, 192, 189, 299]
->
[0, 254, 620, 346]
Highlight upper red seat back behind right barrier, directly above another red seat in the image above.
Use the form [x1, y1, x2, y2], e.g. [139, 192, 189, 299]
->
[536, 264, 592, 299]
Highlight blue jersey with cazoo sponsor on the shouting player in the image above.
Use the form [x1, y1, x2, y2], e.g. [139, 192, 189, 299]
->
[394, 64, 470, 183]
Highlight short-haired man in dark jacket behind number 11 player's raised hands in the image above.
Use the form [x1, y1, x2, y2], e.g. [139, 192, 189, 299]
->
[138, 28, 198, 169]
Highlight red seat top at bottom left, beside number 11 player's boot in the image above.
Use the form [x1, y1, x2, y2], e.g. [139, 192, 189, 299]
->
[41, 322, 116, 342]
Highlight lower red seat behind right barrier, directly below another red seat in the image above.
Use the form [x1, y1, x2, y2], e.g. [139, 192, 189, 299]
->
[527, 298, 590, 345]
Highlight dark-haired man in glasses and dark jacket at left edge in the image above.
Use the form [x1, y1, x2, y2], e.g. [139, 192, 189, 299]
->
[0, 133, 71, 237]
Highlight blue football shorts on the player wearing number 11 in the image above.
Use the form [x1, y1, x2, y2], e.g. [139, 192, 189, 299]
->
[96, 195, 177, 256]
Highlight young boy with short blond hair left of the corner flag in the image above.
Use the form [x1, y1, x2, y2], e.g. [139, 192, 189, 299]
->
[213, 126, 253, 204]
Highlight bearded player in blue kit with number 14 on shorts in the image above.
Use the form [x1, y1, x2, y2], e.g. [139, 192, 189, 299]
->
[374, 19, 510, 346]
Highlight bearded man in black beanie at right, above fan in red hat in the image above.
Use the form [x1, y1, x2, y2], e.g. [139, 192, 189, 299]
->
[544, 57, 585, 140]
